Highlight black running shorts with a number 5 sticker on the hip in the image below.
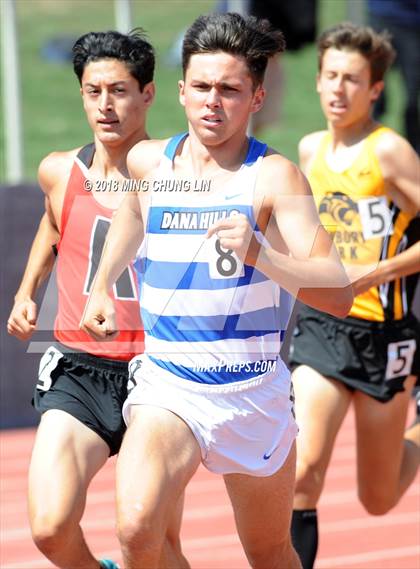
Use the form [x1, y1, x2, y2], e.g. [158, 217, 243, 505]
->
[289, 306, 420, 402]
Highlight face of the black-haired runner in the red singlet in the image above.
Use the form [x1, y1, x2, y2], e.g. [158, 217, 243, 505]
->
[80, 59, 154, 146]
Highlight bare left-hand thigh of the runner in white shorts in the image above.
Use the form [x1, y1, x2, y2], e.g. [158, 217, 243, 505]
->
[117, 405, 201, 532]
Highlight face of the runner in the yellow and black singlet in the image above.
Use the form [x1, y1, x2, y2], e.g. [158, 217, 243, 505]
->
[317, 48, 383, 128]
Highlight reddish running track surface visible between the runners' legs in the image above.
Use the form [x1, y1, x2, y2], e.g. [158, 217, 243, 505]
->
[0, 408, 420, 569]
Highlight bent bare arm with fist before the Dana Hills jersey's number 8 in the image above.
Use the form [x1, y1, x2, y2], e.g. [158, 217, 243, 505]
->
[208, 155, 353, 317]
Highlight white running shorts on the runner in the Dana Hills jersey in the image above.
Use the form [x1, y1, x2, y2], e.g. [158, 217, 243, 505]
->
[123, 354, 298, 476]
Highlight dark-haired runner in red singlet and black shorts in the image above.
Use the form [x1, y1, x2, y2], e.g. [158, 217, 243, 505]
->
[8, 31, 186, 569]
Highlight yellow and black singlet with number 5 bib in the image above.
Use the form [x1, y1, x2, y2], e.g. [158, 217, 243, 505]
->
[308, 126, 413, 321]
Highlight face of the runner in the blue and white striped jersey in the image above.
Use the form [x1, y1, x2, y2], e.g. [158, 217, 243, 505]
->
[179, 52, 264, 145]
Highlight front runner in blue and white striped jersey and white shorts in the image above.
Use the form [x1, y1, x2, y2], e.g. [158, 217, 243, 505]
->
[81, 14, 352, 569]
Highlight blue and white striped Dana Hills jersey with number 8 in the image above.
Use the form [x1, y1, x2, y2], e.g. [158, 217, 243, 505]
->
[135, 134, 290, 384]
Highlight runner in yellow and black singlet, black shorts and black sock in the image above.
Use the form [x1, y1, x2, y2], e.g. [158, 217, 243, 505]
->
[289, 24, 420, 569]
